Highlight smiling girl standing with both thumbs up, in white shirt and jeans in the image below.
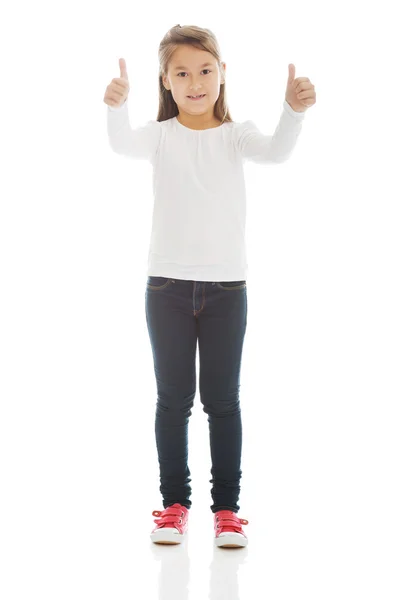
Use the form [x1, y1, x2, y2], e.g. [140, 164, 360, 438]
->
[104, 25, 315, 547]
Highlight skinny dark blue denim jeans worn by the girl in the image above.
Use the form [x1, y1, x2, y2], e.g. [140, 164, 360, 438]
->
[145, 276, 247, 513]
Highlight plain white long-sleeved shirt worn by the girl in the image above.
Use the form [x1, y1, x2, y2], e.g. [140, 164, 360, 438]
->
[107, 100, 305, 281]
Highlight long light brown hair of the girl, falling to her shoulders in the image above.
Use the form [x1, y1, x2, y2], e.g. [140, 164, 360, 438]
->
[157, 25, 232, 125]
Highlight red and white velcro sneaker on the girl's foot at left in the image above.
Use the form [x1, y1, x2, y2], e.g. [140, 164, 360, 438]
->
[150, 502, 189, 544]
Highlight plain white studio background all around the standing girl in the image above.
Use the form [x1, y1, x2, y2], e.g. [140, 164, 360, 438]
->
[0, 0, 400, 600]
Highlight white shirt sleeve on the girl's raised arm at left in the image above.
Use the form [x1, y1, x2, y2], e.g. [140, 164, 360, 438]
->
[107, 101, 161, 162]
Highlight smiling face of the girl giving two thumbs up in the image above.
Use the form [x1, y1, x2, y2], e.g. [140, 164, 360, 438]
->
[163, 45, 226, 119]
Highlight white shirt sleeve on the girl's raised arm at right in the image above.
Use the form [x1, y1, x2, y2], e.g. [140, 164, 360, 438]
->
[234, 100, 305, 164]
